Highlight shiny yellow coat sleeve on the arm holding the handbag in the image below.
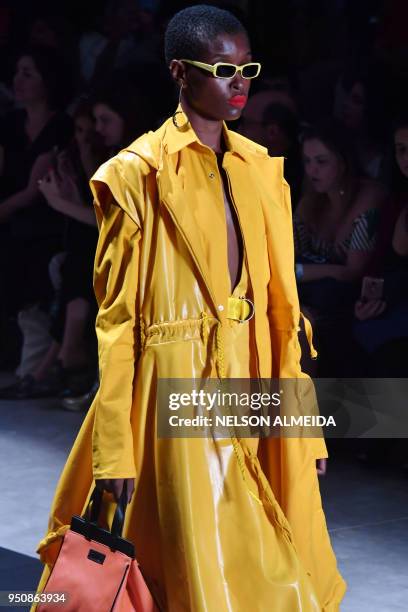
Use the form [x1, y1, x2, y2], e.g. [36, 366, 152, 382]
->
[91, 160, 141, 479]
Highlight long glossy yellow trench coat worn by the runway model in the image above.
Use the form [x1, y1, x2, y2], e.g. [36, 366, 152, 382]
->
[33, 116, 346, 612]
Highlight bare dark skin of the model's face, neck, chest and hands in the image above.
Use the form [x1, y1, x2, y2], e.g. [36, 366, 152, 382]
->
[96, 33, 326, 499]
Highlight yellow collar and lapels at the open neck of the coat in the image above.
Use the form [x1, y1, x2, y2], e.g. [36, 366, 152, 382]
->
[124, 113, 267, 317]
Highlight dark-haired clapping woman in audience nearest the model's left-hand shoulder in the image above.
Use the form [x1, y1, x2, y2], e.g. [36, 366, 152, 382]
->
[0, 81, 155, 402]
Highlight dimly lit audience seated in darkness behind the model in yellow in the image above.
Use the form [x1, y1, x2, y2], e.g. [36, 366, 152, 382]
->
[0, 0, 408, 416]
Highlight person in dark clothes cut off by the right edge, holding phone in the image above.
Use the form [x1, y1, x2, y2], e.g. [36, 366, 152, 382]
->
[353, 123, 408, 471]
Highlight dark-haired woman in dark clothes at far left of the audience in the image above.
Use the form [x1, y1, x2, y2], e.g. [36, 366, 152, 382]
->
[0, 47, 72, 366]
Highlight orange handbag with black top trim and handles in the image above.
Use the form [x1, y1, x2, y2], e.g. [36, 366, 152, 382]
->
[37, 481, 159, 612]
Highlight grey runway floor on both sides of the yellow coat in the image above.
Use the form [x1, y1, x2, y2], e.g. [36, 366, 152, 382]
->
[0, 376, 408, 612]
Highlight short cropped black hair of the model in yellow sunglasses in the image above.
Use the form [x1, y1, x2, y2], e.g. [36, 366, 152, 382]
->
[164, 4, 248, 65]
